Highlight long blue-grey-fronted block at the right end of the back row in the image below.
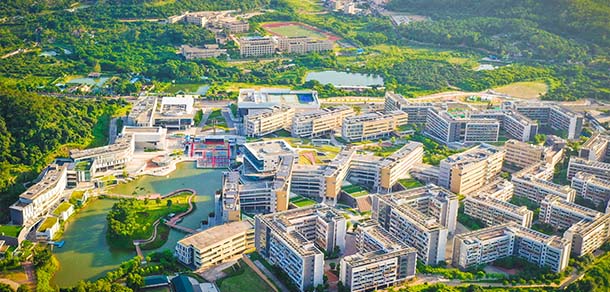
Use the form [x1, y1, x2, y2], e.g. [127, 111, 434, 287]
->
[502, 102, 583, 140]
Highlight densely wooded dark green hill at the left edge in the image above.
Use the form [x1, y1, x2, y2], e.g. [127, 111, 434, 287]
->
[0, 88, 122, 219]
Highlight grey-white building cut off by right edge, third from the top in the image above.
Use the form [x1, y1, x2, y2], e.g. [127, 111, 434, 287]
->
[572, 172, 610, 209]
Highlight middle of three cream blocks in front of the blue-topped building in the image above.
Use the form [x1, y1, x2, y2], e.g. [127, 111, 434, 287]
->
[291, 105, 355, 138]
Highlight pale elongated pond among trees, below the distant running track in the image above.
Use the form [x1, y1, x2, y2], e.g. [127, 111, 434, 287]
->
[305, 71, 383, 87]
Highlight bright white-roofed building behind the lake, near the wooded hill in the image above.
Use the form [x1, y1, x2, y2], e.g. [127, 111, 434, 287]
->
[153, 95, 195, 130]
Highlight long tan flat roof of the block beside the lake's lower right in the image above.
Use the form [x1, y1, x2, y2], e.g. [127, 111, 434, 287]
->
[178, 220, 254, 249]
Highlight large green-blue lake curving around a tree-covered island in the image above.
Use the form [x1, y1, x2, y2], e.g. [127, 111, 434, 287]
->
[53, 162, 222, 287]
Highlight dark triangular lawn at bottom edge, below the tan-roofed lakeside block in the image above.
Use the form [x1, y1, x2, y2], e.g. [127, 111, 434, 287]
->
[216, 260, 272, 292]
